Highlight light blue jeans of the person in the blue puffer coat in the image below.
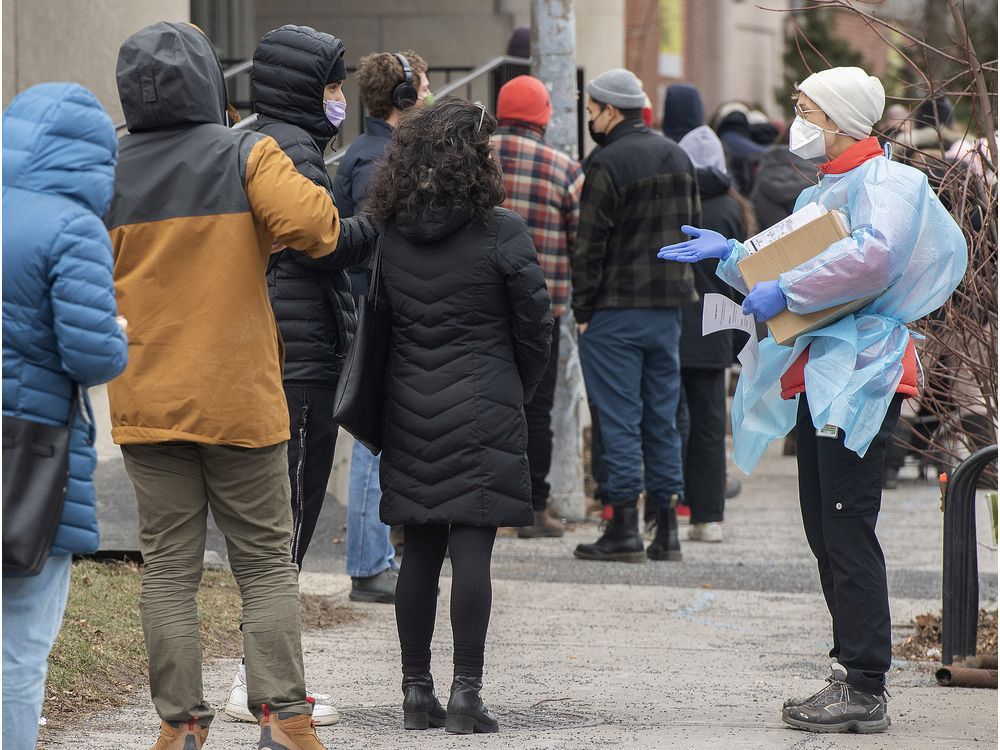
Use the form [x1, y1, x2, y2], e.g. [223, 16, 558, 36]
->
[3, 555, 73, 750]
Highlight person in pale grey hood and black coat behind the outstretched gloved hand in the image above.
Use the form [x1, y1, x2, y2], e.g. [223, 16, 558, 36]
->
[677, 125, 756, 542]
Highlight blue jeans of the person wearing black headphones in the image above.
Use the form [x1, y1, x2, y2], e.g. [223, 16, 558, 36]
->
[347, 442, 396, 578]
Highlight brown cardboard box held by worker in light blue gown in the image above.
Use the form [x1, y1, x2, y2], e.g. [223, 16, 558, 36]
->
[737, 211, 873, 346]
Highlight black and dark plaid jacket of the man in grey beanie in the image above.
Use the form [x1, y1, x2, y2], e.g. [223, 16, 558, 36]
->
[570, 119, 701, 323]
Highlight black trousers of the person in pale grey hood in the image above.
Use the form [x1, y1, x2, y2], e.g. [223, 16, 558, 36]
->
[677, 367, 726, 523]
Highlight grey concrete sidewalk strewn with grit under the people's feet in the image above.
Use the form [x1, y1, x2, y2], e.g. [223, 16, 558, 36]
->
[45, 444, 997, 750]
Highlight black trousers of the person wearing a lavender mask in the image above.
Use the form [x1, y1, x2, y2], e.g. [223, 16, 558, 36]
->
[285, 385, 338, 569]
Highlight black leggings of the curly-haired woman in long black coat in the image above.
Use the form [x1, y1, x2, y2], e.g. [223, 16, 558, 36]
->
[396, 524, 497, 677]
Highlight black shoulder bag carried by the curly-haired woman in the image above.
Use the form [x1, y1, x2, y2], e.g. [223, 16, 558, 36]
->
[333, 232, 392, 456]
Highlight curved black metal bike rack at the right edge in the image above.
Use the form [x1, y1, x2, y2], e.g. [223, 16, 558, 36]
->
[941, 445, 997, 665]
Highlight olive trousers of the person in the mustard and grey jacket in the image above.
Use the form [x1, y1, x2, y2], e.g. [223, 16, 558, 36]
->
[122, 442, 312, 726]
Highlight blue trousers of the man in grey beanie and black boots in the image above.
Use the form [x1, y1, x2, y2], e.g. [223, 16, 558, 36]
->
[580, 307, 684, 508]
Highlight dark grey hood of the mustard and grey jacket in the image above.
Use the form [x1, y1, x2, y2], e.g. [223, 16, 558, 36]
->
[115, 21, 226, 132]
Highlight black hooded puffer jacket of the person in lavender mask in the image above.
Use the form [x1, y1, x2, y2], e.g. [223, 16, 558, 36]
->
[251, 26, 375, 388]
